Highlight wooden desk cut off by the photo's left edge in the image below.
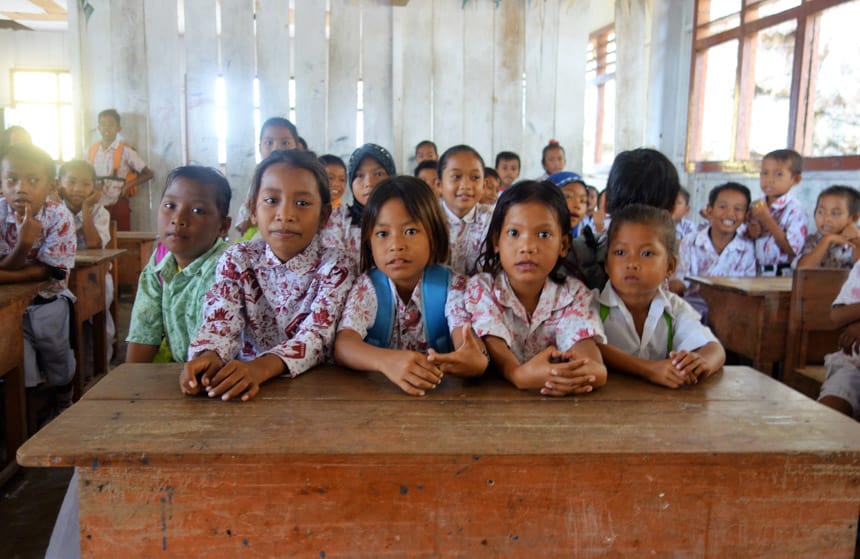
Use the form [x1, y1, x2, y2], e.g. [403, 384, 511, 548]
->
[0, 281, 48, 485]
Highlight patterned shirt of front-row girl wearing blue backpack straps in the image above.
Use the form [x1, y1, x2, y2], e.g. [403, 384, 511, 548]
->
[337, 266, 469, 353]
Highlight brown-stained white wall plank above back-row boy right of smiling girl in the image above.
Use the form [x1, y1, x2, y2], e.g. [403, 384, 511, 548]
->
[491, 2, 525, 168]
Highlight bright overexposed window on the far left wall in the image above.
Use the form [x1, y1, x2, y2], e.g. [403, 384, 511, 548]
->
[5, 70, 75, 161]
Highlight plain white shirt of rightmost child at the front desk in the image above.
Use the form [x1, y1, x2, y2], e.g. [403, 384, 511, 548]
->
[592, 281, 719, 361]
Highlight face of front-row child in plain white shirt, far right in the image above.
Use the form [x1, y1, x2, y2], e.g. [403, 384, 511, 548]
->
[606, 223, 676, 302]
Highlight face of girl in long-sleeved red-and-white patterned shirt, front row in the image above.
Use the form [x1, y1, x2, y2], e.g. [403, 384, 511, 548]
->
[254, 163, 331, 262]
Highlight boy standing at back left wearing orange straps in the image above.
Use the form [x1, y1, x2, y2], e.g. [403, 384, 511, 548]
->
[89, 109, 152, 231]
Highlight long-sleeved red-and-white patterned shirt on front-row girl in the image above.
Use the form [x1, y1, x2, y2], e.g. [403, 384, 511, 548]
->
[188, 236, 353, 377]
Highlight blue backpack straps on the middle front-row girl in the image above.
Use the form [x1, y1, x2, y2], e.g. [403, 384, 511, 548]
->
[364, 264, 454, 353]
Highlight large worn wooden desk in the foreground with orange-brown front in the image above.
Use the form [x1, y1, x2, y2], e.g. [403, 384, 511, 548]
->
[18, 365, 860, 558]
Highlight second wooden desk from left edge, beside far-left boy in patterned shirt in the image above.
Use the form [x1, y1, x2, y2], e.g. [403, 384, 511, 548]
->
[69, 249, 125, 400]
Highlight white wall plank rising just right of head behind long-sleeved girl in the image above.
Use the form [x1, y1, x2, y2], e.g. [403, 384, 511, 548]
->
[295, 0, 328, 151]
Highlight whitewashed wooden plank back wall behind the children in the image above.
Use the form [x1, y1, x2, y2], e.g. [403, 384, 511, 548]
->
[73, 0, 589, 229]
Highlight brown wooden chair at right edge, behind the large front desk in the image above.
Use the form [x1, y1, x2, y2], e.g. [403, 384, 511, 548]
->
[782, 268, 848, 398]
